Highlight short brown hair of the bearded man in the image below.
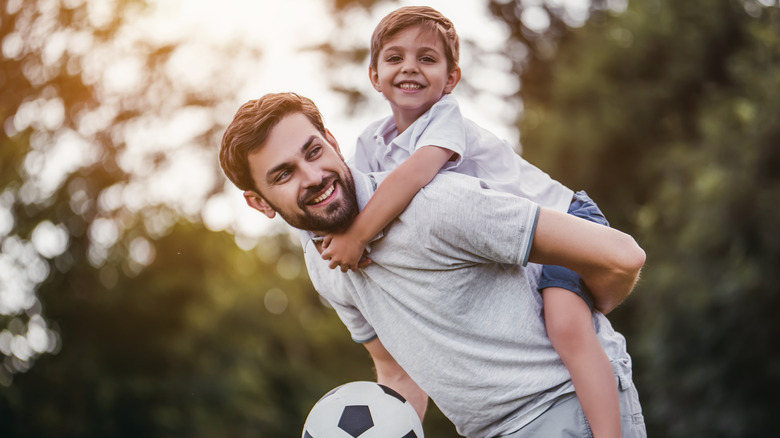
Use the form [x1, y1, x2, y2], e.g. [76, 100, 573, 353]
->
[219, 93, 325, 194]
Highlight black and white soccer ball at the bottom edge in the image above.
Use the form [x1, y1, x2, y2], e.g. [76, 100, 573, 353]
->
[302, 382, 424, 438]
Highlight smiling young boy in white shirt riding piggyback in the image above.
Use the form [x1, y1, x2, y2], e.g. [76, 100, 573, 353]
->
[322, 7, 621, 438]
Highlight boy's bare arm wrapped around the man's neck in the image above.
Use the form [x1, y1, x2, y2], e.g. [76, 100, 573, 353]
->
[322, 146, 453, 272]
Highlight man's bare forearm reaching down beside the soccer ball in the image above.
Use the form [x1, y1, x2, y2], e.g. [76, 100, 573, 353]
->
[363, 338, 428, 421]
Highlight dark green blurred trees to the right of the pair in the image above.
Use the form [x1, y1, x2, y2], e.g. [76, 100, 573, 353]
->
[491, 0, 780, 437]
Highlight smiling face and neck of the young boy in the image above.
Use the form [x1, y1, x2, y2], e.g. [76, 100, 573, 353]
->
[369, 26, 460, 133]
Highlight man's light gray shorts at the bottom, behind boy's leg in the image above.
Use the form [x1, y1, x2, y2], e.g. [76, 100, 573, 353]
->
[502, 363, 647, 438]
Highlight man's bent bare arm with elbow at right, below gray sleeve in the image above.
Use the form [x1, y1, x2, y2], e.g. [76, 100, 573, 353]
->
[529, 208, 645, 314]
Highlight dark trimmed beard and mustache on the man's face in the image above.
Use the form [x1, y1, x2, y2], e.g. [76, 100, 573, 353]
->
[266, 169, 359, 233]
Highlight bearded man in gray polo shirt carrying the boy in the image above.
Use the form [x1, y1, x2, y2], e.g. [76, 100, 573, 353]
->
[220, 93, 645, 437]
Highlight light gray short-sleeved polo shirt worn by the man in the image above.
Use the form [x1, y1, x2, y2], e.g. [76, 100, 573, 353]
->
[301, 169, 630, 437]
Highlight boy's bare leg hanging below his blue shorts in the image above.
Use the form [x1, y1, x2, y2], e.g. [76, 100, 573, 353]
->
[542, 287, 621, 438]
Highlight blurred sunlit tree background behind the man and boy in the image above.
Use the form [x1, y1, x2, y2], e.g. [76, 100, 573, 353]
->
[0, 0, 780, 438]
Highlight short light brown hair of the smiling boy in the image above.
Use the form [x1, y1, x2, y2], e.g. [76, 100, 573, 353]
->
[371, 6, 460, 71]
